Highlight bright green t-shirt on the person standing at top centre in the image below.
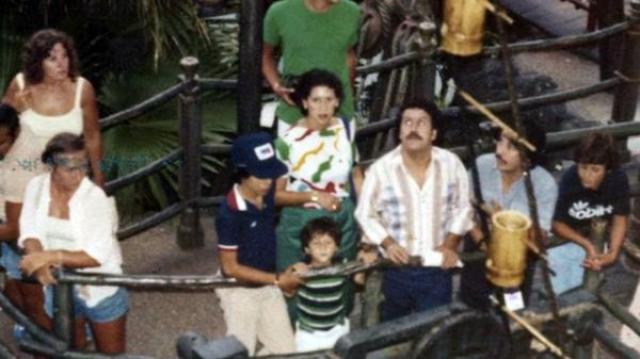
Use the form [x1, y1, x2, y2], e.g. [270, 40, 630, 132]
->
[263, 0, 360, 124]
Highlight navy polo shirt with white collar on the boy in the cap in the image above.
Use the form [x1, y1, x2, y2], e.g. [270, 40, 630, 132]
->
[216, 184, 276, 272]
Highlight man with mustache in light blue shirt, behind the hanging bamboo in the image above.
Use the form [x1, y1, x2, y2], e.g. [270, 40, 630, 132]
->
[460, 122, 558, 307]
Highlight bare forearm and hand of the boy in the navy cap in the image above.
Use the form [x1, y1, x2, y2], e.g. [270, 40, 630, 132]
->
[219, 250, 302, 293]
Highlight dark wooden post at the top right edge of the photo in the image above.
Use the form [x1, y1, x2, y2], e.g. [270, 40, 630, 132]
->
[612, 0, 640, 122]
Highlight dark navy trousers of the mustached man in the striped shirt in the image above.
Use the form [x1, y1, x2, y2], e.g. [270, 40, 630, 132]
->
[380, 267, 452, 322]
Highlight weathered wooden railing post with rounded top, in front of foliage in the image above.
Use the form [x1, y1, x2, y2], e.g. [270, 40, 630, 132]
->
[176, 56, 204, 249]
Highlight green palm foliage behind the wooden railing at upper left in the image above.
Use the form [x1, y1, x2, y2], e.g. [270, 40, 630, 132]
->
[0, 0, 237, 218]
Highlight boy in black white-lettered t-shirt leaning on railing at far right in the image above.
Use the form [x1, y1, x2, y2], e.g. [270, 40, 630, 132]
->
[553, 133, 630, 271]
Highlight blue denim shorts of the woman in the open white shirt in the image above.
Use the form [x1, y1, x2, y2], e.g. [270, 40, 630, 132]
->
[44, 286, 129, 323]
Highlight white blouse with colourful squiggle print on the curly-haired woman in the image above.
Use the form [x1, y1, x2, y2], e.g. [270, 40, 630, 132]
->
[276, 120, 358, 197]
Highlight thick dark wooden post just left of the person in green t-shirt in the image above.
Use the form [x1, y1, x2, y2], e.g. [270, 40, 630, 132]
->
[236, 0, 264, 134]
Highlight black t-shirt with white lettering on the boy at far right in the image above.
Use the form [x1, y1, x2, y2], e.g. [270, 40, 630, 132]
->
[553, 165, 630, 228]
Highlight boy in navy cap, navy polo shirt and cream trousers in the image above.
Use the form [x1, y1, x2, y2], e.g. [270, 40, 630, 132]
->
[216, 132, 302, 356]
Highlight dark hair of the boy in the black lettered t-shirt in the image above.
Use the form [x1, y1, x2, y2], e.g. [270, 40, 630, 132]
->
[573, 133, 620, 170]
